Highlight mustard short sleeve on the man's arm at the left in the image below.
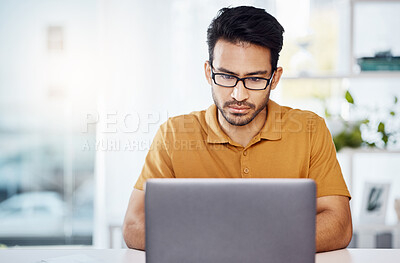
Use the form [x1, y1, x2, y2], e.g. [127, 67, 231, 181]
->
[135, 123, 175, 190]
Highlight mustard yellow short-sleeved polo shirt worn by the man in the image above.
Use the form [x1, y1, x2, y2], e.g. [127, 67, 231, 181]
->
[135, 100, 350, 197]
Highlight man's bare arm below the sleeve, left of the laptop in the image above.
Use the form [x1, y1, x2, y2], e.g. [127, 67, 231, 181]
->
[122, 189, 145, 250]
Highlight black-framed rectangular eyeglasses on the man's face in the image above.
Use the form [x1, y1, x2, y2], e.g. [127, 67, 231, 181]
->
[211, 66, 275, 90]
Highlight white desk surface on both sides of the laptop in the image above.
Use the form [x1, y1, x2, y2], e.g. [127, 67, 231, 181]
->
[0, 249, 400, 263]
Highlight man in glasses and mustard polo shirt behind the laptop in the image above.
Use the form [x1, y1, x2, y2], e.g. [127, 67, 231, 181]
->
[123, 7, 352, 252]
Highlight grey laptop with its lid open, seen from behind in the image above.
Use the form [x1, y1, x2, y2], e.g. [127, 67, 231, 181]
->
[145, 179, 316, 263]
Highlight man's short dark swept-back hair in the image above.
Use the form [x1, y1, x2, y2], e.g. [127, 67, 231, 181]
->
[207, 6, 285, 70]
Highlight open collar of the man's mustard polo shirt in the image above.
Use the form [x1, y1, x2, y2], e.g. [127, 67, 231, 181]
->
[205, 100, 282, 143]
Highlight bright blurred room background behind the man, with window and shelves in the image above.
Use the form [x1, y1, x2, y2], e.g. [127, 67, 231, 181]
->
[0, 0, 400, 248]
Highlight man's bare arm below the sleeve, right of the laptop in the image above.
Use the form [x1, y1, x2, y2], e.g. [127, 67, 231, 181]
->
[316, 195, 353, 252]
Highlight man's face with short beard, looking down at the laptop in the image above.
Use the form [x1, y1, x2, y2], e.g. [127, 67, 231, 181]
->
[205, 40, 281, 129]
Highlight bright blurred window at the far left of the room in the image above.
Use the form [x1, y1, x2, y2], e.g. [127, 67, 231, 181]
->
[0, 1, 96, 246]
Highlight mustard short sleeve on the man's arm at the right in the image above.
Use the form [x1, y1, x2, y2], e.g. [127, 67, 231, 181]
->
[309, 117, 351, 198]
